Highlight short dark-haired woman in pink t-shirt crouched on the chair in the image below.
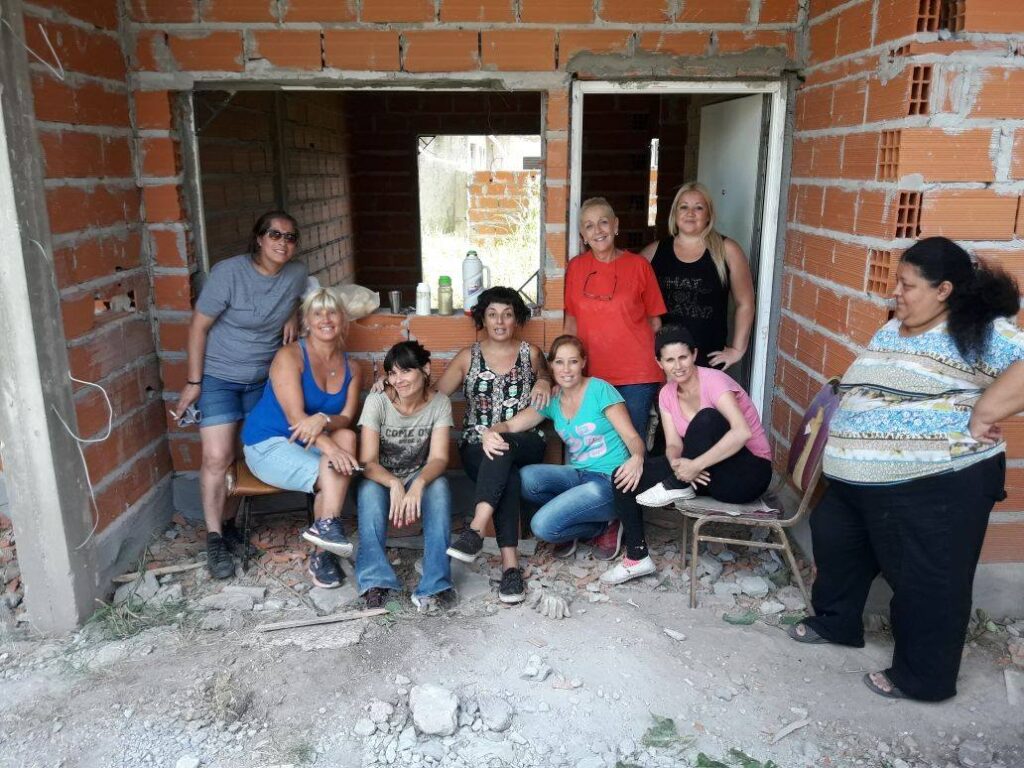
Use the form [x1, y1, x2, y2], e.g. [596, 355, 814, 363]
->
[637, 326, 771, 507]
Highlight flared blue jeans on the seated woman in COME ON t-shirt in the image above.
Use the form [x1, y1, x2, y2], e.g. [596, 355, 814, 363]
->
[355, 474, 452, 597]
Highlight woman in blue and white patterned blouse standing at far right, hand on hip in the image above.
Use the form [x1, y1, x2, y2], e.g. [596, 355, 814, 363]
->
[790, 238, 1024, 701]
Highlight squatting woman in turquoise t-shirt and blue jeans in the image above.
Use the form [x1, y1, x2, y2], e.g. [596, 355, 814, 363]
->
[482, 336, 654, 575]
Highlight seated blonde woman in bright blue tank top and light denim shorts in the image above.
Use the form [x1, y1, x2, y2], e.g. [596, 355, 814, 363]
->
[242, 288, 359, 588]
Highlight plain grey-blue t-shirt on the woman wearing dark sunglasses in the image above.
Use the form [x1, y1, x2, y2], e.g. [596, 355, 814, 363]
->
[196, 254, 306, 384]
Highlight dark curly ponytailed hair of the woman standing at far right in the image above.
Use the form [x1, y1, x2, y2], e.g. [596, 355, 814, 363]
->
[901, 238, 1020, 365]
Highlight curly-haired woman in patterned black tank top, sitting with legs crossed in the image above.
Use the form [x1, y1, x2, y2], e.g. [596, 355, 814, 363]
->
[437, 287, 551, 603]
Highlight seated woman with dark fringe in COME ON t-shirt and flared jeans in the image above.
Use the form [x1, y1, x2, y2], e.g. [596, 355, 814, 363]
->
[355, 341, 455, 612]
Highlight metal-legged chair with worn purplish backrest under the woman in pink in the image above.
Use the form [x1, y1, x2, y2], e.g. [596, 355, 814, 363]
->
[675, 379, 840, 614]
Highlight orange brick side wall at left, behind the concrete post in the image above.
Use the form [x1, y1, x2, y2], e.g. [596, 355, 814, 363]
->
[25, 0, 172, 530]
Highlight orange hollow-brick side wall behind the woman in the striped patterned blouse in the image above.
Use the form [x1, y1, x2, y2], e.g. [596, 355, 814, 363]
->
[772, 0, 1024, 561]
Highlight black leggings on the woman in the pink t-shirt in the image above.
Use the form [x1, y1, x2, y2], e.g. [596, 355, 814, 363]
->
[615, 408, 771, 560]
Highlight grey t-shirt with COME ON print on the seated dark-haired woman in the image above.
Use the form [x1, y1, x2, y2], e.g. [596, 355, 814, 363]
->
[359, 392, 453, 482]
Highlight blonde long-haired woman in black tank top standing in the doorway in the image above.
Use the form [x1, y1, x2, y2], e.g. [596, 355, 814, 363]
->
[641, 181, 754, 371]
